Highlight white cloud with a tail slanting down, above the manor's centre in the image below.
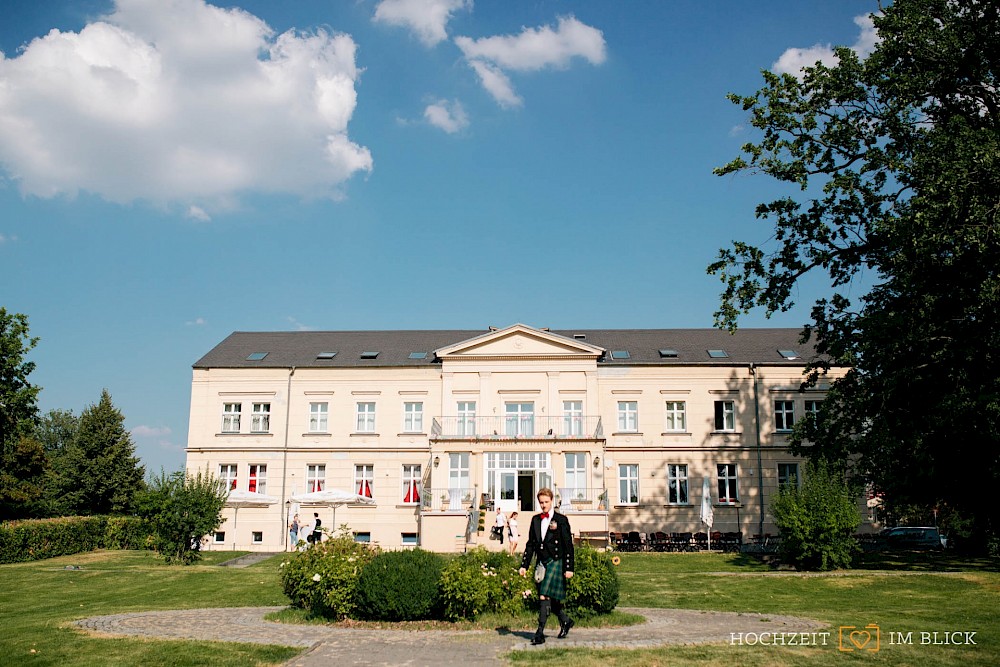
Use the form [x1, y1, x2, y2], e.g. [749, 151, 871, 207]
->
[455, 16, 607, 108]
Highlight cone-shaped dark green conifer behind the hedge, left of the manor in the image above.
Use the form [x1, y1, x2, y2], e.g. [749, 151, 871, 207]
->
[56, 389, 145, 515]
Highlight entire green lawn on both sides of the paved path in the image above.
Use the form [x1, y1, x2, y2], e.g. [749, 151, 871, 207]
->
[0, 551, 1000, 667]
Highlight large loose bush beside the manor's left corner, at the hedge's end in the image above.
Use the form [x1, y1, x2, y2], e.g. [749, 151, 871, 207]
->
[136, 470, 229, 565]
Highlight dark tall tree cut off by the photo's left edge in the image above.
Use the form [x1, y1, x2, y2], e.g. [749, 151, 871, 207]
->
[0, 307, 47, 518]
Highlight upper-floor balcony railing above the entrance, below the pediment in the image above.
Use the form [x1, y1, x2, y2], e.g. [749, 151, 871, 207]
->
[431, 415, 604, 440]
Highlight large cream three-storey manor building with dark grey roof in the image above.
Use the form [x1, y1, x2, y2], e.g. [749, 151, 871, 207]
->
[187, 324, 852, 551]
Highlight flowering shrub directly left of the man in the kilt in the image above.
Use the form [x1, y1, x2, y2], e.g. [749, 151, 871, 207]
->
[441, 547, 534, 621]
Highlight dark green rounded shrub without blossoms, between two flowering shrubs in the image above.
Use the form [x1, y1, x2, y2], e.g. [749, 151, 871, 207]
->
[357, 549, 444, 621]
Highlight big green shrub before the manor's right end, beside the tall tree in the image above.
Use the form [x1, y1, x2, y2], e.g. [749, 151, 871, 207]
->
[771, 462, 861, 570]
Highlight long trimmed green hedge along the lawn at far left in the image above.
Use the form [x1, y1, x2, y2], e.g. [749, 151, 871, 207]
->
[0, 516, 150, 563]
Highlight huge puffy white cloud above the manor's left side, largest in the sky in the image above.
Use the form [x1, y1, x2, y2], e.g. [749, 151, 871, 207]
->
[0, 0, 372, 210]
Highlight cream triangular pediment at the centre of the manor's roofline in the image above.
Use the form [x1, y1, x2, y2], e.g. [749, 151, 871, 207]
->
[435, 324, 604, 359]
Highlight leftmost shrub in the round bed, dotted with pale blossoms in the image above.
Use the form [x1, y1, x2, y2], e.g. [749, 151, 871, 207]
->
[280, 535, 378, 619]
